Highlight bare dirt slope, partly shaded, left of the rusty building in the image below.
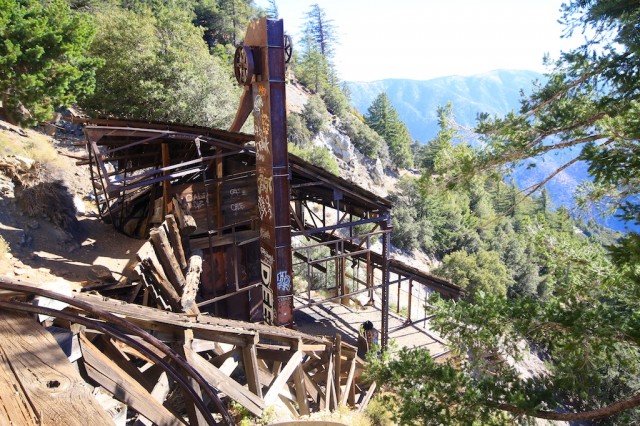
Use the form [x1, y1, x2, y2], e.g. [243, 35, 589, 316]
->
[0, 123, 143, 286]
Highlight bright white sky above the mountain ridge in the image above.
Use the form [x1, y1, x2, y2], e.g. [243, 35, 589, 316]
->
[256, 0, 580, 81]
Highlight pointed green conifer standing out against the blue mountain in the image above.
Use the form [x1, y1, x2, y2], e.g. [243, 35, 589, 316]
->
[365, 93, 413, 168]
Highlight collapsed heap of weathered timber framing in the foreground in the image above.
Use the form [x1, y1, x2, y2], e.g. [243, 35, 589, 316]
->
[0, 279, 375, 425]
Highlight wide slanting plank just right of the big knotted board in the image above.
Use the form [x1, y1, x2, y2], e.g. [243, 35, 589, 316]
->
[80, 334, 184, 426]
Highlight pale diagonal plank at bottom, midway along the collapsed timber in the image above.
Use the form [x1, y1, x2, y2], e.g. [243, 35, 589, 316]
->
[184, 347, 265, 416]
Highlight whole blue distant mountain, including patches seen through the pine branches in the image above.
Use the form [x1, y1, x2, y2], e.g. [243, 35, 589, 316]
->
[346, 70, 640, 232]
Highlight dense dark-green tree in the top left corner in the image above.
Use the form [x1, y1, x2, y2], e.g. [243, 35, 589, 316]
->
[0, 0, 100, 124]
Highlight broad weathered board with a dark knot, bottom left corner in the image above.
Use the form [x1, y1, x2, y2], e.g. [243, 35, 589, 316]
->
[0, 311, 113, 426]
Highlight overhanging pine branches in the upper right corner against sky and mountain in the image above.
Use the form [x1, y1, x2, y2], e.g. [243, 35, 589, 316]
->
[470, 0, 640, 270]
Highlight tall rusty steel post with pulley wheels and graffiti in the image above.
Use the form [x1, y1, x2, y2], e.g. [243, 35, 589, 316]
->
[231, 18, 293, 327]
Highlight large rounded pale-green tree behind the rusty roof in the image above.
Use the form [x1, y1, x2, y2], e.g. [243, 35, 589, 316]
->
[82, 2, 238, 127]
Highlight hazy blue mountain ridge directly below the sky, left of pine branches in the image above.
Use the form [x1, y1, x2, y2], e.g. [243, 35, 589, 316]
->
[346, 70, 543, 143]
